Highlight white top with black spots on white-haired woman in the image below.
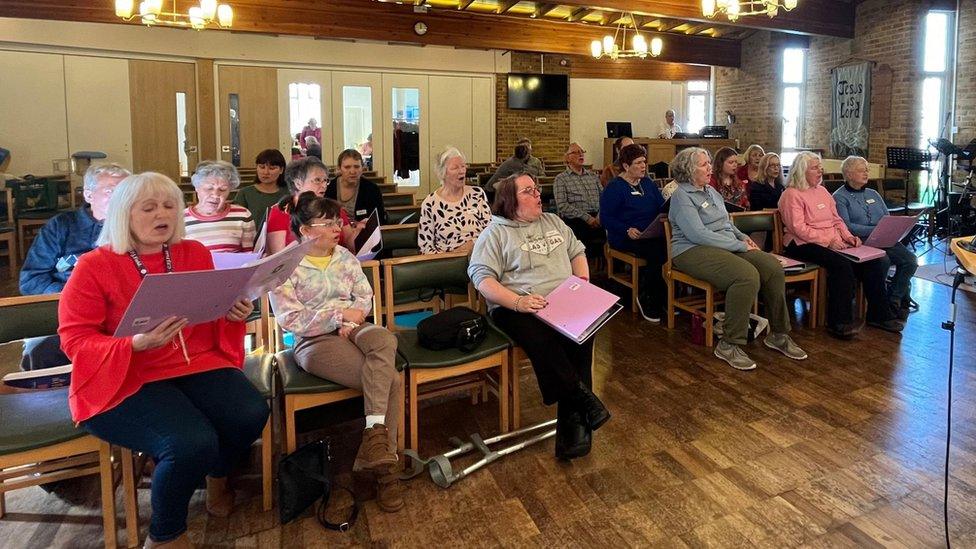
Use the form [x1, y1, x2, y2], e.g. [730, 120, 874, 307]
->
[417, 185, 491, 254]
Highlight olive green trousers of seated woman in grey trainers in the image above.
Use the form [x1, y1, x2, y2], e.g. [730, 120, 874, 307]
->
[672, 246, 790, 345]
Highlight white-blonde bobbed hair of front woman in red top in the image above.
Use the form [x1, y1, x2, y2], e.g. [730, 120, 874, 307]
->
[97, 172, 186, 254]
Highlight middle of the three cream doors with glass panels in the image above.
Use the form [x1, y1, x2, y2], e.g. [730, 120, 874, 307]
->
[332, 72, 388, 175]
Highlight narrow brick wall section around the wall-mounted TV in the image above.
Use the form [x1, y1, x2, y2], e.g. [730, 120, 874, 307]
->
[495, 52, 569, 162]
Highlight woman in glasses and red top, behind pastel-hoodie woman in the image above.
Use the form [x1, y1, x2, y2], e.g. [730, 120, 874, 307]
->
[267, 156, 359, 255]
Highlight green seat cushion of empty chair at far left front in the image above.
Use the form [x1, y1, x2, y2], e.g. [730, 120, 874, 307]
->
[0, 389, 87, 455]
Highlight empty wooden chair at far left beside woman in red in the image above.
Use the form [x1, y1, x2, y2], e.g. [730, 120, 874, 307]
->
[0, 294, 126, 548]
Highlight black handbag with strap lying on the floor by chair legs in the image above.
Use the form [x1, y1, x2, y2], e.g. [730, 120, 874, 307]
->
[278, 439, 359, 532]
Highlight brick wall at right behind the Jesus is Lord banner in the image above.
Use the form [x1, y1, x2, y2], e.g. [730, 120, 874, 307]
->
[715, 0, 976, 167]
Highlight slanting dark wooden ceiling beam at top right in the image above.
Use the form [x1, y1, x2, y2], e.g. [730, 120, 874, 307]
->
[544, 0, 854, 38]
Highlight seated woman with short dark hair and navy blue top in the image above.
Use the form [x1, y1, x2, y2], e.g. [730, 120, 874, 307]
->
[600, 145, 668, 323]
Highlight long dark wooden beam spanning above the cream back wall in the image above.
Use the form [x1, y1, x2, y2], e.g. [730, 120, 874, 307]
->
[0, 0, 740, 67]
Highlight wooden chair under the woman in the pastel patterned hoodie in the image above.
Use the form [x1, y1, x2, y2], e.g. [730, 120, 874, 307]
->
[275, 261, 405, 454]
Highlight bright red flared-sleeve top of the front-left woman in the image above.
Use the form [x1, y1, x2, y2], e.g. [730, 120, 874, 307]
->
[58, 240, 244, 422]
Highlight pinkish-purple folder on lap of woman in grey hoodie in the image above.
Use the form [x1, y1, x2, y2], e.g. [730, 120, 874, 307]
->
[536, 276, 623, 343]
